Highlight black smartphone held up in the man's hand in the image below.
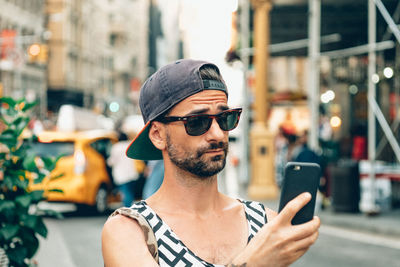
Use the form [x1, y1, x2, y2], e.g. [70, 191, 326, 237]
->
[279, 162, 321, 225]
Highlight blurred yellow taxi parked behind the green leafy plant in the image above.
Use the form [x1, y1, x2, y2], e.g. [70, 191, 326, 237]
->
[30, 130, 117, 213]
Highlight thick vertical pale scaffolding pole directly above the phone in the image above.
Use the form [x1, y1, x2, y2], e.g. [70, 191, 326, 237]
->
[308, 0, 321, 150]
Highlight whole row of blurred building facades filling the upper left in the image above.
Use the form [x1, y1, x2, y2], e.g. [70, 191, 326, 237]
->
[0, 0, 150, 121]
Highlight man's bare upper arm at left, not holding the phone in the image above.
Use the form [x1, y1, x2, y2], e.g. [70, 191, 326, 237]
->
[102, 215, 158, 267]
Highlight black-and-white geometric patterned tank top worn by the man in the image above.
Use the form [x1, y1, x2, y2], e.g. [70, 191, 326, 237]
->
[131, 200, 267, 267]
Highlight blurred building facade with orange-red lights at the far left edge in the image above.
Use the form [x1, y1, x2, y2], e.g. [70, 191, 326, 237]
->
[0, 0, 48, 117]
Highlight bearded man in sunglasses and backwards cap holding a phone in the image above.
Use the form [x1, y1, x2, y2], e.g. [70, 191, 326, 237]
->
[102, 60, 320, 266]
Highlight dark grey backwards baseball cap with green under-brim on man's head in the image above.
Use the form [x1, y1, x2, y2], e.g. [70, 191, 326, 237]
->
[126, 59, 228, 160]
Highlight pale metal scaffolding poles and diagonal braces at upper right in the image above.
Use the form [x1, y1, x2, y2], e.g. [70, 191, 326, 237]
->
[308, 0, 400, 213]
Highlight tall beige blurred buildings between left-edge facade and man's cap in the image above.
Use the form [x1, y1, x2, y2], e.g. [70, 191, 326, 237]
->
[46, 0, 147, 118]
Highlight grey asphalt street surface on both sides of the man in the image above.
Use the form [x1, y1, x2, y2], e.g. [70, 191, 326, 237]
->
[37, 211, 400, 267]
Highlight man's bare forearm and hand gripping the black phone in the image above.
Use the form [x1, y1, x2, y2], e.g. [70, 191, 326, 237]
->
[228, 194, 320, 267]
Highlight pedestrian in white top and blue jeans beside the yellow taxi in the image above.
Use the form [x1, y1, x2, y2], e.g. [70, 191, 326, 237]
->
[107, 132, 139, 207]
